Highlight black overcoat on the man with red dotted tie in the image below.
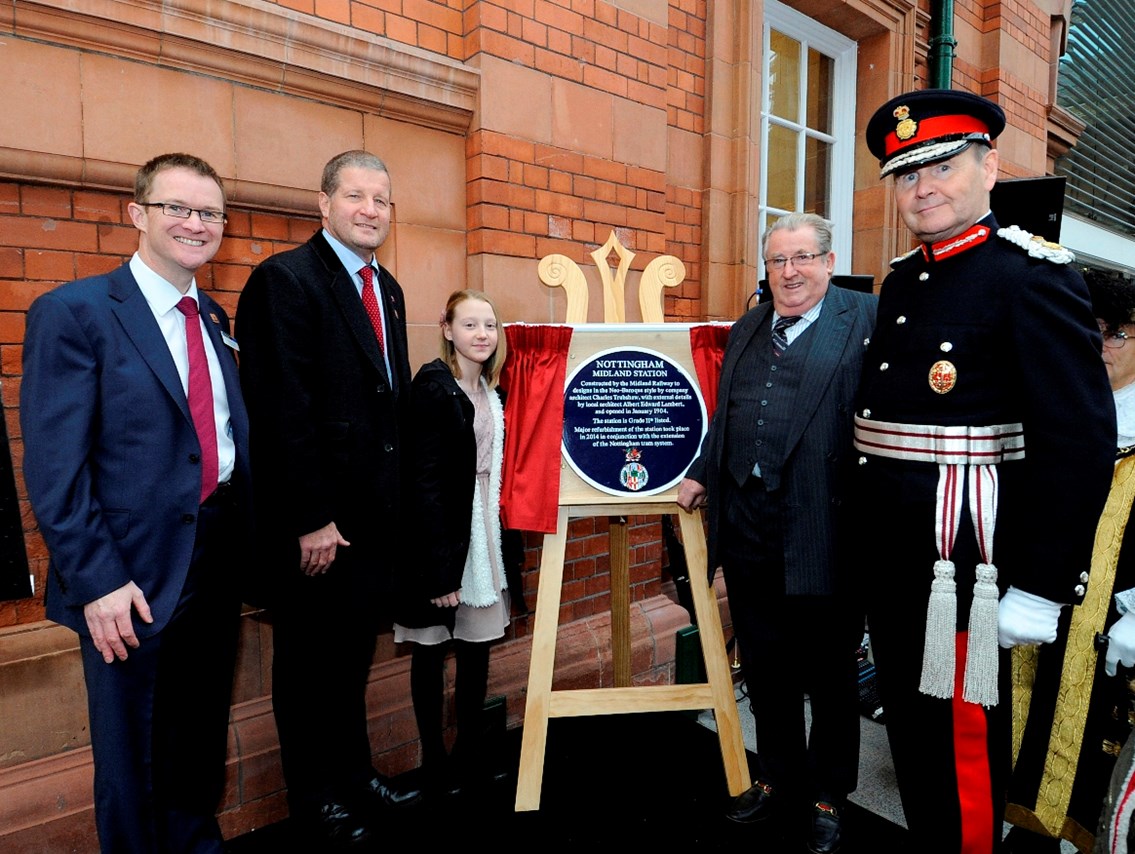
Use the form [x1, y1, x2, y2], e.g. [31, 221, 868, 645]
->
[236, 233, 410, 604]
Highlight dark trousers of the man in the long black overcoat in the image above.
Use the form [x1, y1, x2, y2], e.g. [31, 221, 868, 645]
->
[272, 550, 380, 812]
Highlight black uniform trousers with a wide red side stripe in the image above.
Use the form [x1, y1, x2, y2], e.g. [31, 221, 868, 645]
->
[858, 458, 1012, 854]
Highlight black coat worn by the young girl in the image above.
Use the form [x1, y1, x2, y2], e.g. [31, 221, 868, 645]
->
[396, 359, 503, 628]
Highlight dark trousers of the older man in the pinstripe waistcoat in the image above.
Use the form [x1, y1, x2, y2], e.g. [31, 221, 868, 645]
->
[722, 478, 863, 804]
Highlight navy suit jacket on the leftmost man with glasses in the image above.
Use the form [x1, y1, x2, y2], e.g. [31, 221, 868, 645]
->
[19, 265, 251, 638]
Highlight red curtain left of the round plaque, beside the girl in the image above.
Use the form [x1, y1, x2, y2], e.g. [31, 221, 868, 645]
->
[501, 324, 572, 534]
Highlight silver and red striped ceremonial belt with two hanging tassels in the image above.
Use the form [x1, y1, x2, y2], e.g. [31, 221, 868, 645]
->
[855, 416, 1025, 706]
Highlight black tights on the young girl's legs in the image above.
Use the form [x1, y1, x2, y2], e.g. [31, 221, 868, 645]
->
[410, 641, 489, 773]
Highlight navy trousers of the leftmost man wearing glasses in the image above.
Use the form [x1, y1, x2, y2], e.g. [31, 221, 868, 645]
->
[79, 490, 241, 854]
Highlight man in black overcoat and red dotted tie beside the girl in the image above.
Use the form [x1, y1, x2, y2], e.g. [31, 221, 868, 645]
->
[237, 151, 420, 845]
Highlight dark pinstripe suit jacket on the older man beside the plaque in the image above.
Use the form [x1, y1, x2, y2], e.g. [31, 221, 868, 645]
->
[687, 285, 877, 594]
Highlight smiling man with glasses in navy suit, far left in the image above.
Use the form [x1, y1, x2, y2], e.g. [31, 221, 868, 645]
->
[20, 154, 250, 852]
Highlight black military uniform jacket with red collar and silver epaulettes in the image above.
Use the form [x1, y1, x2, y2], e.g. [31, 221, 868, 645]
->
[857, 215, 1116, 618]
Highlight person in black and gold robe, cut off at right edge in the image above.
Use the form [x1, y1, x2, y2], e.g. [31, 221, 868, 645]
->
[1004, 270, 1135, 854]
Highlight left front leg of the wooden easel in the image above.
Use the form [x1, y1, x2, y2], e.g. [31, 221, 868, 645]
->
[515, 506, 568, 812]
